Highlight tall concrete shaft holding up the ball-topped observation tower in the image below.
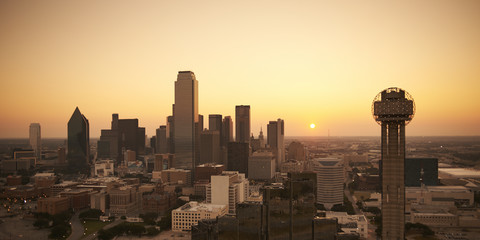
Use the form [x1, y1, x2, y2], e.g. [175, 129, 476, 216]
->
[382, 121, 405, 240]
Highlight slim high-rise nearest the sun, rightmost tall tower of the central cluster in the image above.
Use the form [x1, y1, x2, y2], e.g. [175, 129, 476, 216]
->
[267, 118, 285, 171]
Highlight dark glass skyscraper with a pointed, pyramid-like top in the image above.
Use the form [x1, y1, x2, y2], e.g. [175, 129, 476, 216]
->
[67, 107, 90, 171]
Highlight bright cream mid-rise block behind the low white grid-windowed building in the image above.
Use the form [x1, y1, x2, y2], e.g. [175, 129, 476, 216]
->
[207, 171, 249, 215]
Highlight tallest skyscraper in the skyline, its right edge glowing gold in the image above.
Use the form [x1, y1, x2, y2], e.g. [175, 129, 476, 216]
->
[173, 71, 199, 170]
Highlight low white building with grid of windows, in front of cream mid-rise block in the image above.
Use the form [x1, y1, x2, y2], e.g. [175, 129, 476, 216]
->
[172, 201, 227, 231]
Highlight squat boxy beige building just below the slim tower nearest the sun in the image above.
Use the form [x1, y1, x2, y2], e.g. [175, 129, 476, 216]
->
[248, 151, 275, 180]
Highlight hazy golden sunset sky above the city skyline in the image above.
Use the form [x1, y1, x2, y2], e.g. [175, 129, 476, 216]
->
[0, 0, 480, 138]
